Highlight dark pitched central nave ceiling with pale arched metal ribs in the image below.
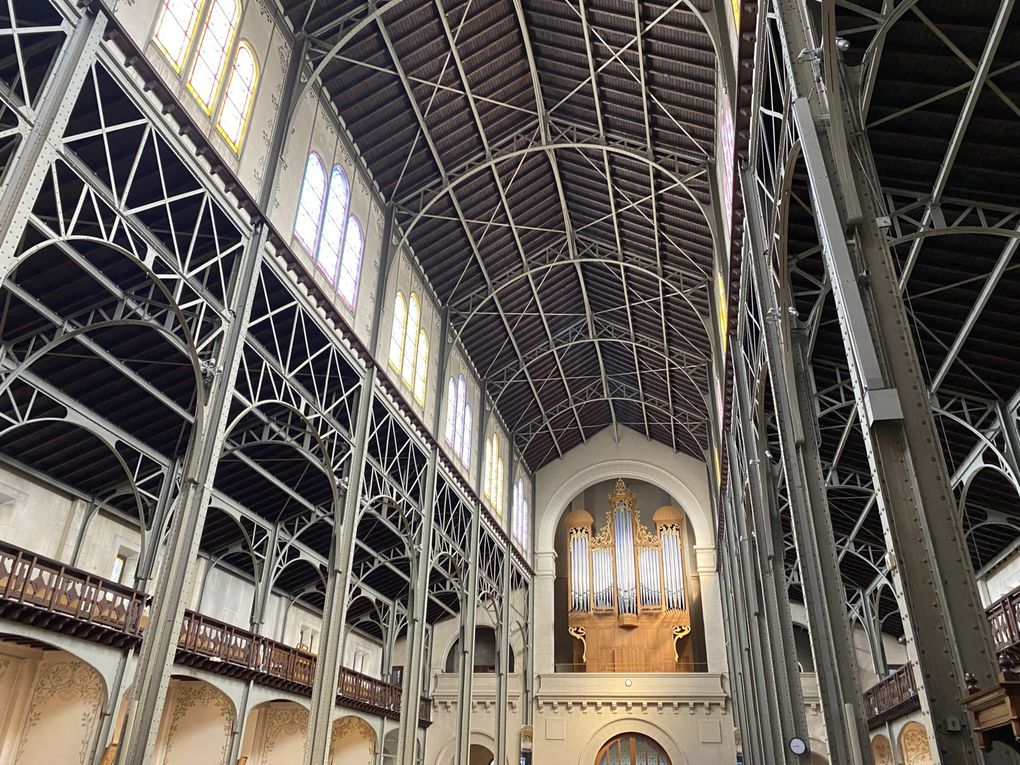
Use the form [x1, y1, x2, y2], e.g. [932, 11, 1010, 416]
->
[279, 0, 715, 468]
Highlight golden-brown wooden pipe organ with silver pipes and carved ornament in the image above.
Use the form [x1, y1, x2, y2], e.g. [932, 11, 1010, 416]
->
[563, 478, 694, 672]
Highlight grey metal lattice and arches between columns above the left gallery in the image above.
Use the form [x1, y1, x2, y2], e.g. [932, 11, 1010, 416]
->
[0, 7, 529, 754]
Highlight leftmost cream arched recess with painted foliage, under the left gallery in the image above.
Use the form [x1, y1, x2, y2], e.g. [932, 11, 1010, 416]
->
[0, 640, 106, 765]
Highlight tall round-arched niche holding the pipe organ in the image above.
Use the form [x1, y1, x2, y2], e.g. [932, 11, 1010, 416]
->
[552, 477, 708, 672]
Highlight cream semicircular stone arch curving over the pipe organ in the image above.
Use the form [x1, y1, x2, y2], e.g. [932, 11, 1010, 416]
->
[536, 460, 715, 551]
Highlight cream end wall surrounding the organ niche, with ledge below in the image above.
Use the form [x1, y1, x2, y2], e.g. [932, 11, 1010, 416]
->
[532, 427, 736, 765]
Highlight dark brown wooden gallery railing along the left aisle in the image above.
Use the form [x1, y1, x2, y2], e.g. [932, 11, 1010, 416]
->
[0, 541, 431, 726]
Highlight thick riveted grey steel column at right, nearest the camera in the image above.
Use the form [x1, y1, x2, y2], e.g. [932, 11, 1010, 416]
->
[779, 0, 1005, 765]
